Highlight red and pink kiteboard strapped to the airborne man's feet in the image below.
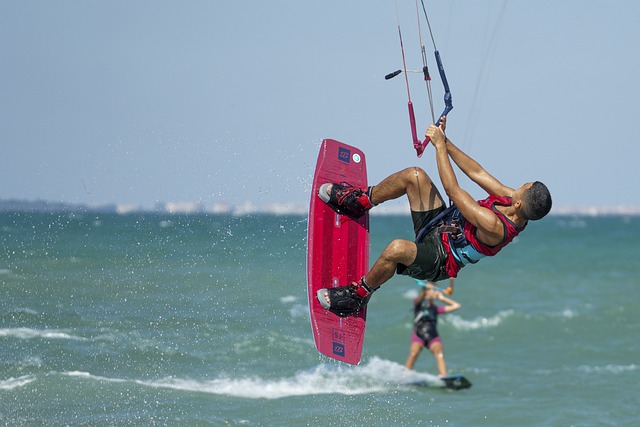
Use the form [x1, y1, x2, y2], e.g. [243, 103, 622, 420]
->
[307, 139, 369, 365]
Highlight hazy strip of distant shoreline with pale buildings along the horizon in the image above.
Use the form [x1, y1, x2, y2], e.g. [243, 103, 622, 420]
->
[0, 199, 640, 216]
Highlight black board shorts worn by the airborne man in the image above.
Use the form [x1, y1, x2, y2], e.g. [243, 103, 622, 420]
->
[396, 205, 449, 282]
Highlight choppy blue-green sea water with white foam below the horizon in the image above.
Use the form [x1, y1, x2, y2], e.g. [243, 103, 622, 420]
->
[0, 213, 640, 427]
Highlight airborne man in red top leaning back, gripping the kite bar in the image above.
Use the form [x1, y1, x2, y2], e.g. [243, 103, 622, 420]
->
[317, 116, 551, 316]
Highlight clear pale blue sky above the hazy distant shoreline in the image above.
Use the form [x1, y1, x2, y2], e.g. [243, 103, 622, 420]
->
[0, 0, 640, 210]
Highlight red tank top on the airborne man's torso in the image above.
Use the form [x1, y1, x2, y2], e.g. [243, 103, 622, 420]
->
[442, 196, 526, 277]
